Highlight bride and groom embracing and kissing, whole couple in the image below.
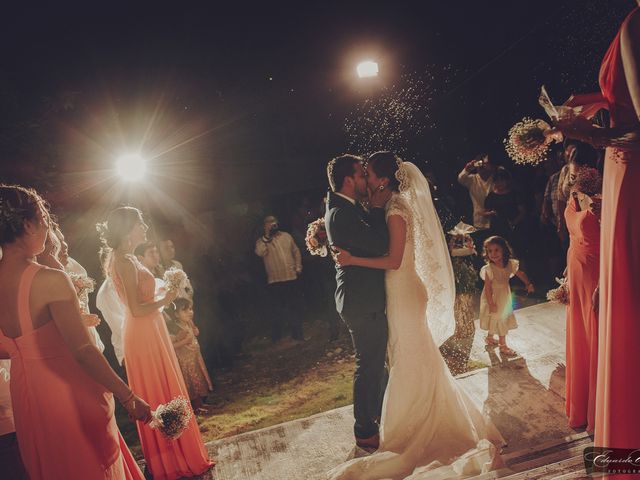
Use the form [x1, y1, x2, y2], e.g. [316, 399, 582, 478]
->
[325, 151, 504, 480]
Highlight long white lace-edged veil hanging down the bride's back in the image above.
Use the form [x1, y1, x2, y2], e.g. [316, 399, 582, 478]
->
[396, 162, 456, 345]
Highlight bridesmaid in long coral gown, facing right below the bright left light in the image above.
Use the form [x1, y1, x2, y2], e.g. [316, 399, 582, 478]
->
[98, 207, 214, 480]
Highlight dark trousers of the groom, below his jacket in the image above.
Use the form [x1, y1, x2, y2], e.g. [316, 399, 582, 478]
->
[341, 310, 389, 438]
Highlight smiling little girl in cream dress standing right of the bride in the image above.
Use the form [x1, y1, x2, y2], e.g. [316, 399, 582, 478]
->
[480, 236, 534, 356]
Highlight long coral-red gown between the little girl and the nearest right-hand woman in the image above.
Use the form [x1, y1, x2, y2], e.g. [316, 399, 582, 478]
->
[564, 198, 600, 432]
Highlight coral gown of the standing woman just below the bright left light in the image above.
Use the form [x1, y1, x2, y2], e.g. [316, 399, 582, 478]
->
[112, 257, 214, 480]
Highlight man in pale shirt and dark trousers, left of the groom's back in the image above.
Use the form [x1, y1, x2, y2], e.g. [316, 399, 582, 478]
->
[255, 215, 304, 343]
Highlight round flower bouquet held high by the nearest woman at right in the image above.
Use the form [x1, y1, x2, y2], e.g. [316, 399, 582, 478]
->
[504, 117, 555, 165]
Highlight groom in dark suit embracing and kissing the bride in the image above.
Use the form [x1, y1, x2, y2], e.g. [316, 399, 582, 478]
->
[325, 155, 391, 451]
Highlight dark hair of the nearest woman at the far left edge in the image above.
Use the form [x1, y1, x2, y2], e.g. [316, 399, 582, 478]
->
[0, 184, 48, 245]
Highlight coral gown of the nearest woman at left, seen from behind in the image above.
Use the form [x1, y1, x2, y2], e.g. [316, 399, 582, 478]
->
[0, 264, 144, 480]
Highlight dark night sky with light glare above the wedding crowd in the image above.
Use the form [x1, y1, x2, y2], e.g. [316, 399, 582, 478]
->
[0, 0, 635, 218]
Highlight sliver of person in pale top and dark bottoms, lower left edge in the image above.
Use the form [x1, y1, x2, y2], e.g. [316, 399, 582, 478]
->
[0, 360, 28, 480]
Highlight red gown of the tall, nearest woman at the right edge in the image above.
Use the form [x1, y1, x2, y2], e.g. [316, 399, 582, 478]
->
[594, 9, 640, 456]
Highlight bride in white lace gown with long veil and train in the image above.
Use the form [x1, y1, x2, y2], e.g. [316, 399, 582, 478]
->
[329, 152, 504, 480]
